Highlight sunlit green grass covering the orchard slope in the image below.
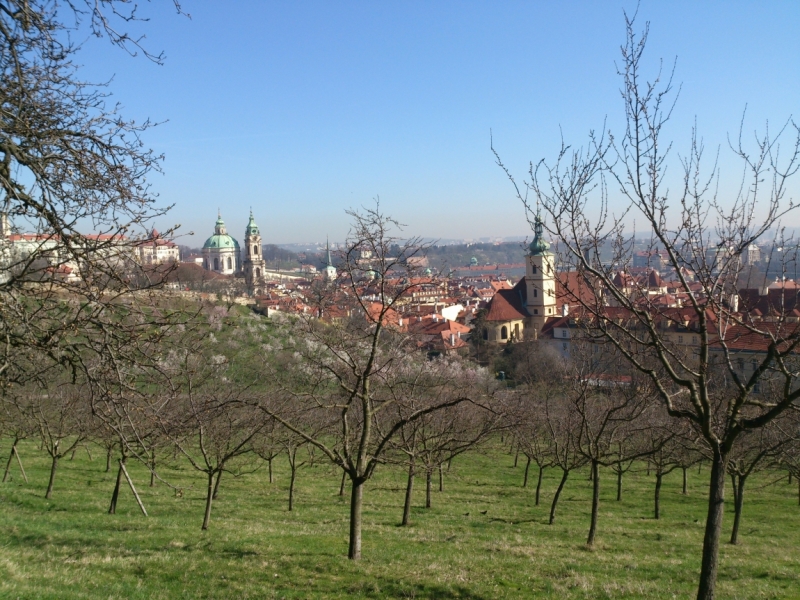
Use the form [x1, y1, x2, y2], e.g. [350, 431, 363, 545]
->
[0, 443, 800, 600]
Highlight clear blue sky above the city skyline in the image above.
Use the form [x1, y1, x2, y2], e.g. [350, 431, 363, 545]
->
[82, 0, 800, 246]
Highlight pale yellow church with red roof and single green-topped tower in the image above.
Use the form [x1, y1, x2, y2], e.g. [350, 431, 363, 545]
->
[482, 214, 569, 344]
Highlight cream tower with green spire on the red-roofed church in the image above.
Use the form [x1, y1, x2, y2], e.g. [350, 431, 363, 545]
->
[525, 212, 556, 337]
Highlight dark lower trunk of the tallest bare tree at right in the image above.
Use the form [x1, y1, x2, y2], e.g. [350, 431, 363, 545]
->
[697, 449, 728, 600]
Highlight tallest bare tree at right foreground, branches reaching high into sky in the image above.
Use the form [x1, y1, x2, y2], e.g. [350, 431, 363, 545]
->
[498, 15, 800, 600]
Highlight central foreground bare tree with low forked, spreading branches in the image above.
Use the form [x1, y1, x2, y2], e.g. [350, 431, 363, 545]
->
[262, 204, 494, 560]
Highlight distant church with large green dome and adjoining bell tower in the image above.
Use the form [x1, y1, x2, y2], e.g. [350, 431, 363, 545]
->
[203, 211, 266, 294]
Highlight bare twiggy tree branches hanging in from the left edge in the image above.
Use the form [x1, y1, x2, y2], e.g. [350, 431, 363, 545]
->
[0, 0, 194, 440]
